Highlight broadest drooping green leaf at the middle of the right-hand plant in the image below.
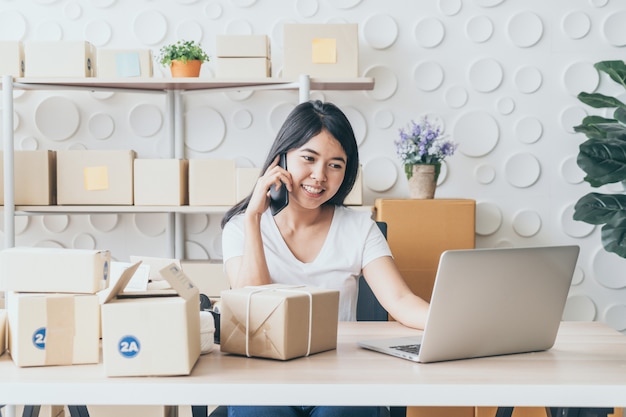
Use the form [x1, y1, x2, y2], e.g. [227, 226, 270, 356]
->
[576, 138, 626, 187]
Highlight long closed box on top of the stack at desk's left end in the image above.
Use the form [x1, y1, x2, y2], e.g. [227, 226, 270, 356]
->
[0, 247, 111, 292]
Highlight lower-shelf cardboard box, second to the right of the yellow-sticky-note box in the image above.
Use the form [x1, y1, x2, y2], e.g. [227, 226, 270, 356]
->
[189, 159, 237, 206]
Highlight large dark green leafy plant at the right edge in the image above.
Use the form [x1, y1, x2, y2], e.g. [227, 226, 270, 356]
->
[574, 61, 626, 258]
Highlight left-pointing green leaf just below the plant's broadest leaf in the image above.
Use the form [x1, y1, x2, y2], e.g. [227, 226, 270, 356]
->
[573, 193, 626, 224]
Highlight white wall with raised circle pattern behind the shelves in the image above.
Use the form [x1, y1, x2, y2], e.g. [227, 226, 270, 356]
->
[0, 0, 626, 330]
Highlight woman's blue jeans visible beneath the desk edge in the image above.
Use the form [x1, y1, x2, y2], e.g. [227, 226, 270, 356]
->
[228, 406, 380, 417]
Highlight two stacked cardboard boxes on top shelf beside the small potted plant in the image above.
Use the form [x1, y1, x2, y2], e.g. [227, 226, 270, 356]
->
[215, 35, 271, 78]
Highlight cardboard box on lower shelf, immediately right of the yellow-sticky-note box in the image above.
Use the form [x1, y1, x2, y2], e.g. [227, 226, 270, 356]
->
[133, 159, 189, 206]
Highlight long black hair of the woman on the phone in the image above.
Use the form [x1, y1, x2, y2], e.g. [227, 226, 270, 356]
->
[221, 100, 359, 227]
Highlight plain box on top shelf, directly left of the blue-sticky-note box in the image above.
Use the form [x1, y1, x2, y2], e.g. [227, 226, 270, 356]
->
[24, 41, 96, 78]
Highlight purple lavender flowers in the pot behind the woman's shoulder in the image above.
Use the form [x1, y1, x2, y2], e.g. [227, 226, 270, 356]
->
[395, 117, 458, 178]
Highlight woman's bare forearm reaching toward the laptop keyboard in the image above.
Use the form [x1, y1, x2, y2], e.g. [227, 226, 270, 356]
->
[363, 256, 429, 329]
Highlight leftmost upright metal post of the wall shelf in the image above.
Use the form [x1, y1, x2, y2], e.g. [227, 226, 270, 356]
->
[2, 75, 15, 248]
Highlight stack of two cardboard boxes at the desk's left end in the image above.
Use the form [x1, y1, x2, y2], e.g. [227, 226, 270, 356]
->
[0, 247, 111, 367]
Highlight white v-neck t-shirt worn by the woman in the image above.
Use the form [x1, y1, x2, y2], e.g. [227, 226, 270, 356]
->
[222, 206, 391, 321]
